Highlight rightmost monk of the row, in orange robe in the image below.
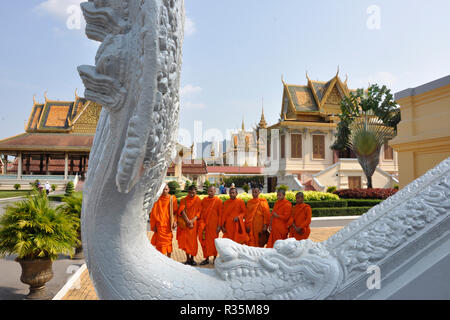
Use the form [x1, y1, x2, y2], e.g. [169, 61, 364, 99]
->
[289, 192, 312, 240]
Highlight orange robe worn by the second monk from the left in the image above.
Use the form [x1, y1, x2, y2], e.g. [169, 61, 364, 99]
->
[177, 196, 202, 256]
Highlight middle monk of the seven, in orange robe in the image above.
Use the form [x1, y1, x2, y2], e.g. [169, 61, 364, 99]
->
[221, 188, 249, 244]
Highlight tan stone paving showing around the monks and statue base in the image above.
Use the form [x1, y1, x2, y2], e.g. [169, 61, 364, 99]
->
[62, 227, 343, 300]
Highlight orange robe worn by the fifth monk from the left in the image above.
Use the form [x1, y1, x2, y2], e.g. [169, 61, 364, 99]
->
[245, 198, 270, 247]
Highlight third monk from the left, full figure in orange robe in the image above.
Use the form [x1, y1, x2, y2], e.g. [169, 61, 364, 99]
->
[198, 186, 222, 266]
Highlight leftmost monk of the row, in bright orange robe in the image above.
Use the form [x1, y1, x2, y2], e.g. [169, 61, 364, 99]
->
[150, 185, 177, 258]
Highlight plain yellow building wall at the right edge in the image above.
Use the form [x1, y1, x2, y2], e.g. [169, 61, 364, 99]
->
[389, 76, 450, 188]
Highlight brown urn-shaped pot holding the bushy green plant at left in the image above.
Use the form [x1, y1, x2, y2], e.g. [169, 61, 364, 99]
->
[16, 258, 53, 300]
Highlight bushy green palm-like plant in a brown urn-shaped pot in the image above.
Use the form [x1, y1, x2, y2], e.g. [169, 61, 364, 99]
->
[0, 191, 80, 299]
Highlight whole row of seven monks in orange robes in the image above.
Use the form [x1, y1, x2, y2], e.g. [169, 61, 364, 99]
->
[150, 185, 312, 266]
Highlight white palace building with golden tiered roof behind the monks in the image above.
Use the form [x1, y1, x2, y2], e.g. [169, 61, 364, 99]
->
[264, 72, 398, 191]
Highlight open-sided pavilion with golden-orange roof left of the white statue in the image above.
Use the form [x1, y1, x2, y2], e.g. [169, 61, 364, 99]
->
[0, 93, 102, 187]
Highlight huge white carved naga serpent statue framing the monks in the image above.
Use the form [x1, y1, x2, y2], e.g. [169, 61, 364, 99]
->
[78, 0, 450, 299]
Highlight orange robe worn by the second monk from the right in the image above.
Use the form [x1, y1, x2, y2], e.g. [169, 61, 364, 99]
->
[267, 199, 292, 248]
